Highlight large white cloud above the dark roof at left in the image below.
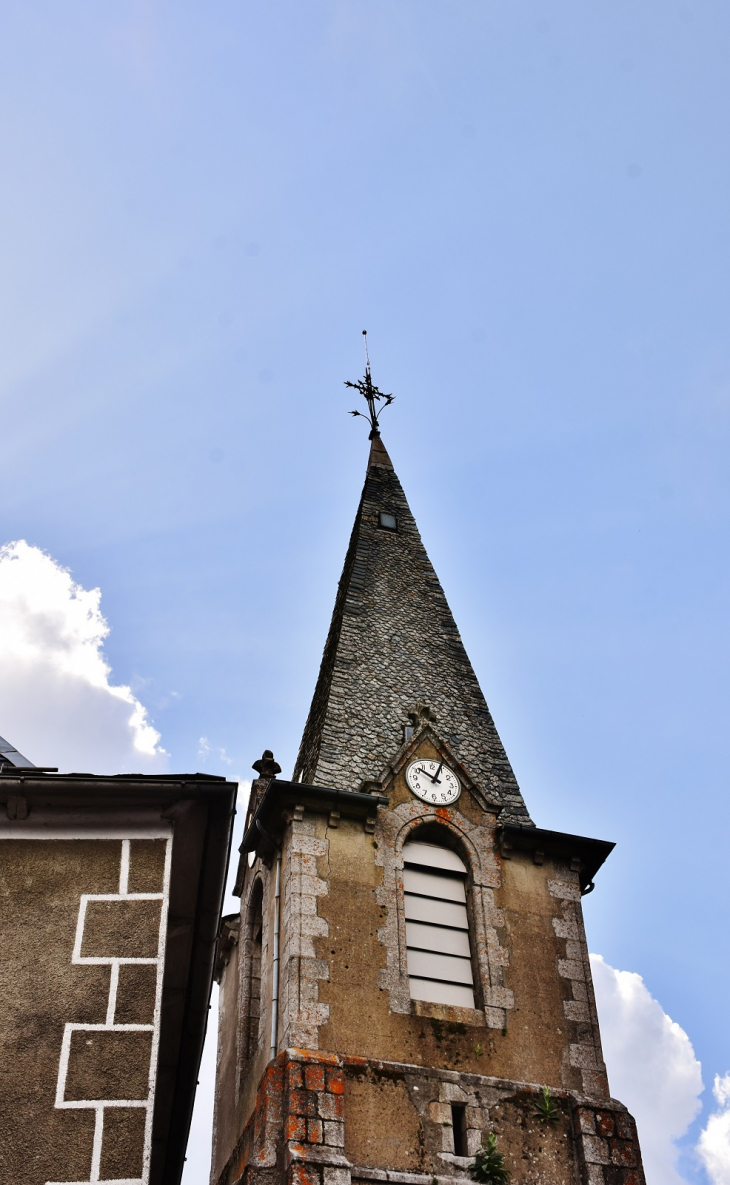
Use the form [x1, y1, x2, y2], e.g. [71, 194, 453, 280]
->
[0, 539, 167, 773]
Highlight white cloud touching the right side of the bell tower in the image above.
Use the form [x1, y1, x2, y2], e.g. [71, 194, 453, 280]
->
[590, 955, 706, 1185]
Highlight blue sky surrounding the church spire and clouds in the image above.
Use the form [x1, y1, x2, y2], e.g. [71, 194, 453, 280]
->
[0, 0, 730, 1185]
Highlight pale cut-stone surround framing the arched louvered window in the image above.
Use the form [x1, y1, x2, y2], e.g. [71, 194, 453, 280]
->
[376, 801, 514, 1029]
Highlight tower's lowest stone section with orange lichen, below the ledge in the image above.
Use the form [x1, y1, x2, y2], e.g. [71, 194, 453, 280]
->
[214, 1049, 645, 1185]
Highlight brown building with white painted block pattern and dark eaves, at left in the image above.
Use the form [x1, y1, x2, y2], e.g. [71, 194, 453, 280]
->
[0, 738, 236, 1185]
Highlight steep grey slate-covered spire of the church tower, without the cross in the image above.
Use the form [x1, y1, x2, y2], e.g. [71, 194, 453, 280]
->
[294, 425, 530, 824]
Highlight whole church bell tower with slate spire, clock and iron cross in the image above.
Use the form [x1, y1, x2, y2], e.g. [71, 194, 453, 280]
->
[211, 370, 645, 1185]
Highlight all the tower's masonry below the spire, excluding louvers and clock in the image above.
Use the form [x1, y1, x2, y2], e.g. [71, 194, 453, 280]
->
[219, 739, 643, 1185]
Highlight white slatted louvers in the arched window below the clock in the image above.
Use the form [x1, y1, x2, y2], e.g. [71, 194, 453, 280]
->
[403, 841, 474, 1008]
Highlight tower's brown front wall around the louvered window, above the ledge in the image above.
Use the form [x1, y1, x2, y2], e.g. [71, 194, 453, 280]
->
[293, 730, 609, 1098]
